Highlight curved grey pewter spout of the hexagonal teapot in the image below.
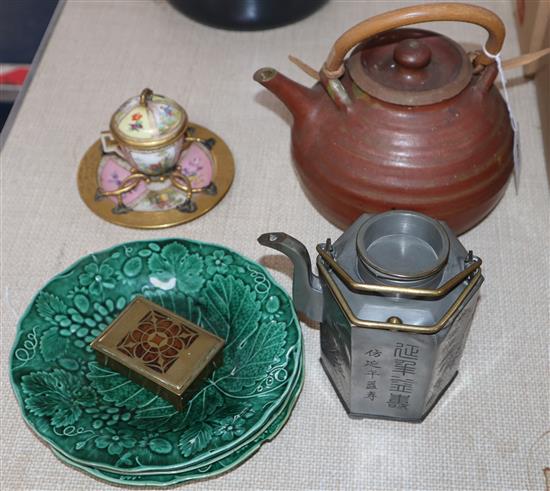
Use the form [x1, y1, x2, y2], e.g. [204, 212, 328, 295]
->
[258, 232, 323, 322]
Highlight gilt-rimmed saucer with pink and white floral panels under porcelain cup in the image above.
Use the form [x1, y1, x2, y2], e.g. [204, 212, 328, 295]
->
[78, 123, 235, 228]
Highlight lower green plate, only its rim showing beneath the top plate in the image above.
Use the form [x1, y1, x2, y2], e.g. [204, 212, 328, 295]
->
[53, 366, 304, 487]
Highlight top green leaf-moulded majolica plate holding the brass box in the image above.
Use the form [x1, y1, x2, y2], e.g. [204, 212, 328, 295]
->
[11, 240, 302, 474]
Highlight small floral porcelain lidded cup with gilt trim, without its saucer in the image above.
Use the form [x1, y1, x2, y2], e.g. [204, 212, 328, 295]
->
[101, 89, 191, 176]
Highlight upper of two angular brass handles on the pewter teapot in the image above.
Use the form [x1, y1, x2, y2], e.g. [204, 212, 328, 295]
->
[317, 244, 482, 298]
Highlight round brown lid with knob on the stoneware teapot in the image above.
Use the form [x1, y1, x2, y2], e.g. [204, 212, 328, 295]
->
[347, 29, 472, 106]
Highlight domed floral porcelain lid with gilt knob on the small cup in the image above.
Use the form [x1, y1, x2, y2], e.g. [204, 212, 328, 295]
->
[110, 89, 187, 148]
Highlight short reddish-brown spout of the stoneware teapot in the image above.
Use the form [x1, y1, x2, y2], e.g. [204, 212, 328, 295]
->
[254, 67, 317, 121]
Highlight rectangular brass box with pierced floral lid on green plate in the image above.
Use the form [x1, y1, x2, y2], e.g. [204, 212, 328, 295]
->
[91, 297, 225, 411]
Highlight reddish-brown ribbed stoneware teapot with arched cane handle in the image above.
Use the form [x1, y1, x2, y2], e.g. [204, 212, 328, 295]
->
[254, 3, 513, 233]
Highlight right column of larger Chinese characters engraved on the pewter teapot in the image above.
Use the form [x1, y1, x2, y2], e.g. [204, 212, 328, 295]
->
[386, 343, 420, 410]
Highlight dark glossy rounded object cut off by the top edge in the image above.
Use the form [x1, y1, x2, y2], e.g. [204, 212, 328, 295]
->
[170, 0, 328, 31]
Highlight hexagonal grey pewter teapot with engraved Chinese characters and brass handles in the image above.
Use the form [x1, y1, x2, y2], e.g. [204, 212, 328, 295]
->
[258, 211, 483, 421]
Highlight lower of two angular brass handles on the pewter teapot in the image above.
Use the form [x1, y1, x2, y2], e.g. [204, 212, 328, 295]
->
[317, 259, 482, 334]
